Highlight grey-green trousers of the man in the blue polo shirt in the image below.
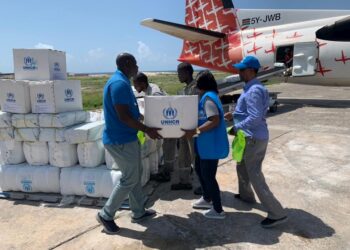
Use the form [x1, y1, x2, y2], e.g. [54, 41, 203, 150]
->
[100, 141, 145, 220]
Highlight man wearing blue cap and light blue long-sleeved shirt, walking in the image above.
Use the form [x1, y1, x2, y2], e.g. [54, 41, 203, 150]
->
[225, 56, 287, 228]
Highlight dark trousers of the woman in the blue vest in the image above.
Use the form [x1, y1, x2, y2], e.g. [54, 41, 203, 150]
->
[195, 155, 223, 213]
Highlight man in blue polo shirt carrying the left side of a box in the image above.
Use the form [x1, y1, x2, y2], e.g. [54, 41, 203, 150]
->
[96, 53, 161, 234]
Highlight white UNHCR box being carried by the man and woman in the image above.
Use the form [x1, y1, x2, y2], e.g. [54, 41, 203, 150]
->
[145, 96, 198, 138]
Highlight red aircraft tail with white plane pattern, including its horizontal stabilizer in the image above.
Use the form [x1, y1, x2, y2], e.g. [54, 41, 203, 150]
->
[141, 0, 243, 73]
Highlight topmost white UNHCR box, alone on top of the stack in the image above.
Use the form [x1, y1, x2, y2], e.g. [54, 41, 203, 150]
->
[13, 49, 67, 81]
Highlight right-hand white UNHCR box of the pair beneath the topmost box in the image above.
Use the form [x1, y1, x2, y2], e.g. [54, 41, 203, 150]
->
[30, 80, 83, 114]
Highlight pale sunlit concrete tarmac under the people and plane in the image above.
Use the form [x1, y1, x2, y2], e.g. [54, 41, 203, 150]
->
[0, 83, 350, 250]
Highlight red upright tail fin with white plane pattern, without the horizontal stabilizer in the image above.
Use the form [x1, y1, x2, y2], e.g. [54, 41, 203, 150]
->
[179, 0, 243, 73]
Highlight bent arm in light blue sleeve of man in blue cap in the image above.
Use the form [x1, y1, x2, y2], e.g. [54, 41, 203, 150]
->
[234, 88, 265, 131]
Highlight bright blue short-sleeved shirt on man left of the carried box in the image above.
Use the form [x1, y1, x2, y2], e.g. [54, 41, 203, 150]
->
[103, 70, 140, 145]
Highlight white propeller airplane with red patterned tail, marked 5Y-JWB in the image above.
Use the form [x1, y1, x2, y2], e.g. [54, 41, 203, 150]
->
[141, 0, 350, 86]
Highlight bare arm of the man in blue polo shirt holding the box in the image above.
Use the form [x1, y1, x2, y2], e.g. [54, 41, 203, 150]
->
[114, 104, 162, 139]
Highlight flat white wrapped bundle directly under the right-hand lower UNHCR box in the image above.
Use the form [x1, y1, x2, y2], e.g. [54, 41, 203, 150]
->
[39, 111, 89, 128]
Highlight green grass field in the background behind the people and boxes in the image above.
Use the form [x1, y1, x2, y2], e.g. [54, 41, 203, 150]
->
[69, 72, 280, 110]
